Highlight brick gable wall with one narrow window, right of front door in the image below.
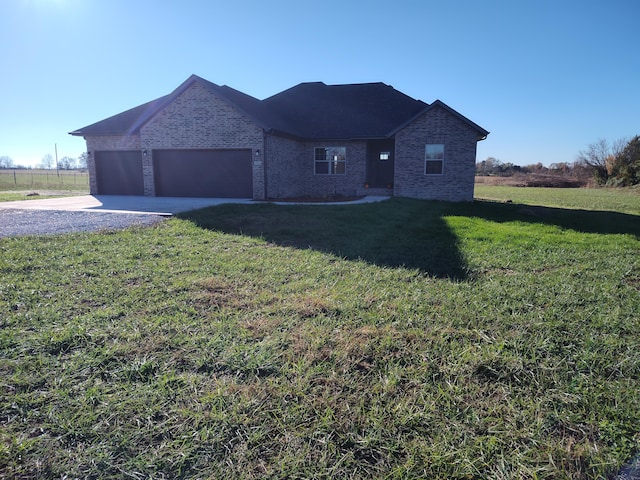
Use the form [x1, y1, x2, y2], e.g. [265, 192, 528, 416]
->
[394, 106, 478, 202]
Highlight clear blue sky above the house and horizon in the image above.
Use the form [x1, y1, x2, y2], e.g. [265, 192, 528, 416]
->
[0, 0, 640, 165]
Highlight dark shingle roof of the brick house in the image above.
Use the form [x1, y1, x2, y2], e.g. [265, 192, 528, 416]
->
[71, 75, 488, 140]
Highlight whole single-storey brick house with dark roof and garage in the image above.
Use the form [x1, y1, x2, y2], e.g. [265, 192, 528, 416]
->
[71, 75, 489, 201]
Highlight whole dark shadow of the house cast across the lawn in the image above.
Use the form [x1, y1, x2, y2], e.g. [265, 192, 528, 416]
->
[179, 198, 640, 280]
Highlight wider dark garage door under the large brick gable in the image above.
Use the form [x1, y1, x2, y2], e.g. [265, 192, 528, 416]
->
[153, 149, 253, 198]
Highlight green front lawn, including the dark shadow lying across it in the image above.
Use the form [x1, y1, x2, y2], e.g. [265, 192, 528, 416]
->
[0, 189, 640, 479]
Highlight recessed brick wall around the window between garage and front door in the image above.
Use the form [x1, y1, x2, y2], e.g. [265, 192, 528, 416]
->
[265, 135, 367, 198]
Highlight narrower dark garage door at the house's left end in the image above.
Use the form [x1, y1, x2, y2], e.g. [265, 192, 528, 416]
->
[94, 150, 144, 195]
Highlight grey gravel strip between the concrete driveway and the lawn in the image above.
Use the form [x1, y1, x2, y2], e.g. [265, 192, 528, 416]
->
[0, 209, 166, 237]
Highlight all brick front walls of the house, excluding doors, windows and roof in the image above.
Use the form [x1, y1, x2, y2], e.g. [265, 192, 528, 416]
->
[80, 82, 477, 201]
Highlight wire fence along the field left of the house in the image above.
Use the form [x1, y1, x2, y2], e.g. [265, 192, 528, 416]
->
[0, 168, 89, 191]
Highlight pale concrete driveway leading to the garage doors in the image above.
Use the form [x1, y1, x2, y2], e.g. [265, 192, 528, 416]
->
[0, 195, 252, 216]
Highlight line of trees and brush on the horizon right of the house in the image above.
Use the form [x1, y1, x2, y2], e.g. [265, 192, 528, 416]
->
[476, 135, 640, 187]
